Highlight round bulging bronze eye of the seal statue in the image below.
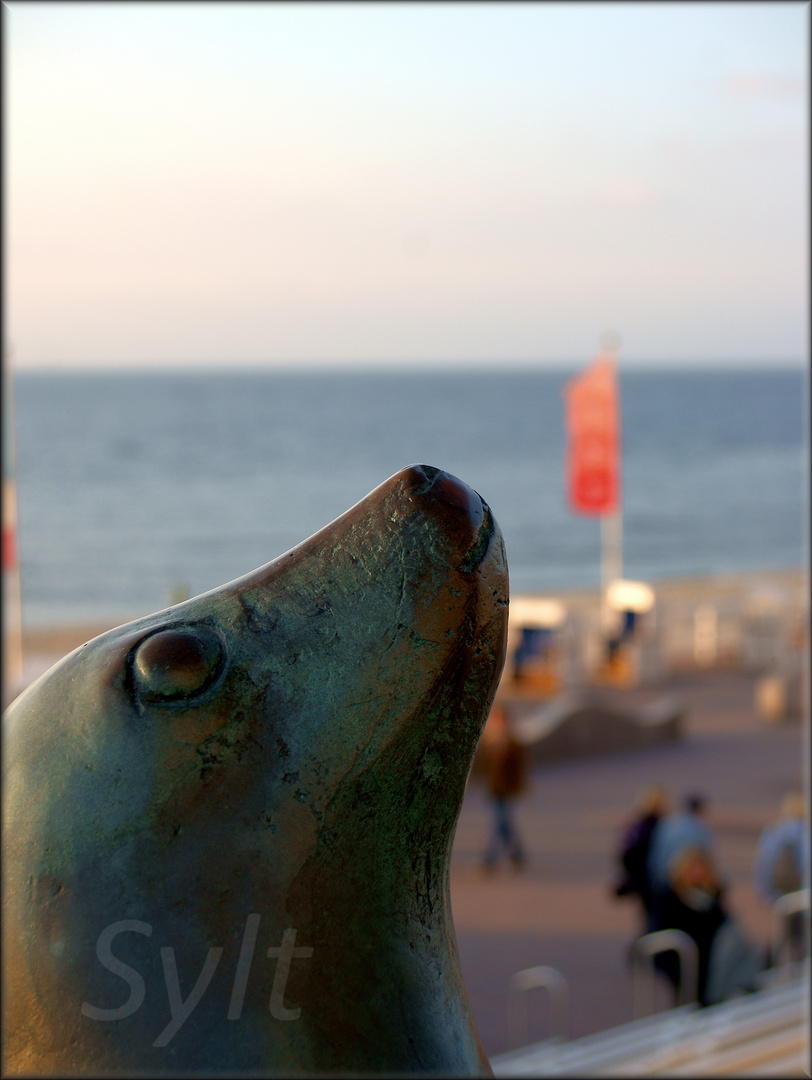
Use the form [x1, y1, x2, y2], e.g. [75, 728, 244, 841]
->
[133, 626, 225, 702]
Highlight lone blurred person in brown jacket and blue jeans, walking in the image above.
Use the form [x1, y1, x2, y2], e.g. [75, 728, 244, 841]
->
[482, 705, 527, 870]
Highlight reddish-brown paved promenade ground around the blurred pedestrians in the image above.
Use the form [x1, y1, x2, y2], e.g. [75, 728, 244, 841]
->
[451, 673, 808, 1055]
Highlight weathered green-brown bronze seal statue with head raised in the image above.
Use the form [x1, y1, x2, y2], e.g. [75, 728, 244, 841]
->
[2, 465, 508, 1075]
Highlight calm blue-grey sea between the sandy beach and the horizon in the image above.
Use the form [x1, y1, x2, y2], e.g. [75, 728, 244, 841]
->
[13, 363, 809, 627]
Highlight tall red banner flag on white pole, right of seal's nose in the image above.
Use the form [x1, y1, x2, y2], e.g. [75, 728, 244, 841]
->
[564, 357, 620, 514]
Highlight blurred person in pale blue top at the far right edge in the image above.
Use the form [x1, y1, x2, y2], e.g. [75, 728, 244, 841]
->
[753, 792, 809, 962]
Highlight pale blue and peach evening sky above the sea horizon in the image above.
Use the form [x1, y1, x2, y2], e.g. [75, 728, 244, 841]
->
[3, 0, 810, 369]
